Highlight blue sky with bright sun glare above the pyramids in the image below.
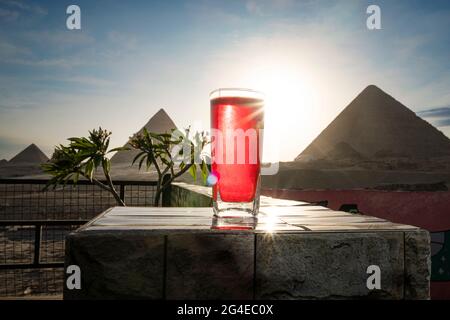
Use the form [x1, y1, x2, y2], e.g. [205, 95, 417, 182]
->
[0, 0, 450, 160]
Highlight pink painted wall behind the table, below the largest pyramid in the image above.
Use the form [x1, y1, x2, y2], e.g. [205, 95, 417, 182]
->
[262, 189, 450, 299]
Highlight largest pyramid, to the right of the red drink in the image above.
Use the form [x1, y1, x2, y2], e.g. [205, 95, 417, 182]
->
[296, 85, 450, 160]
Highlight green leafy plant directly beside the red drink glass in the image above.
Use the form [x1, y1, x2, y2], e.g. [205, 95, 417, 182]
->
[130, 128, 209, 206]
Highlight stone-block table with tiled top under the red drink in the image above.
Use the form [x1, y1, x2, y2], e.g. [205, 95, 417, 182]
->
[64, 197, 430, 299]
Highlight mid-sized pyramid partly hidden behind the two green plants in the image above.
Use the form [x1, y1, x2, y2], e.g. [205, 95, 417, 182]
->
[111, 109, 177, 166]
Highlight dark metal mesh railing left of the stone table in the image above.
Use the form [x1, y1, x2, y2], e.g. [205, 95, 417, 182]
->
[0, 179, 166, 297]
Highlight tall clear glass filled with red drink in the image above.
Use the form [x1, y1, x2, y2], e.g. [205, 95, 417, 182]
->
[210, 89, 264, 219]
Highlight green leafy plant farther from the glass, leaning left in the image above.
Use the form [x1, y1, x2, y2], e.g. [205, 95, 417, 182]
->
[42, 128, 125, 206]
